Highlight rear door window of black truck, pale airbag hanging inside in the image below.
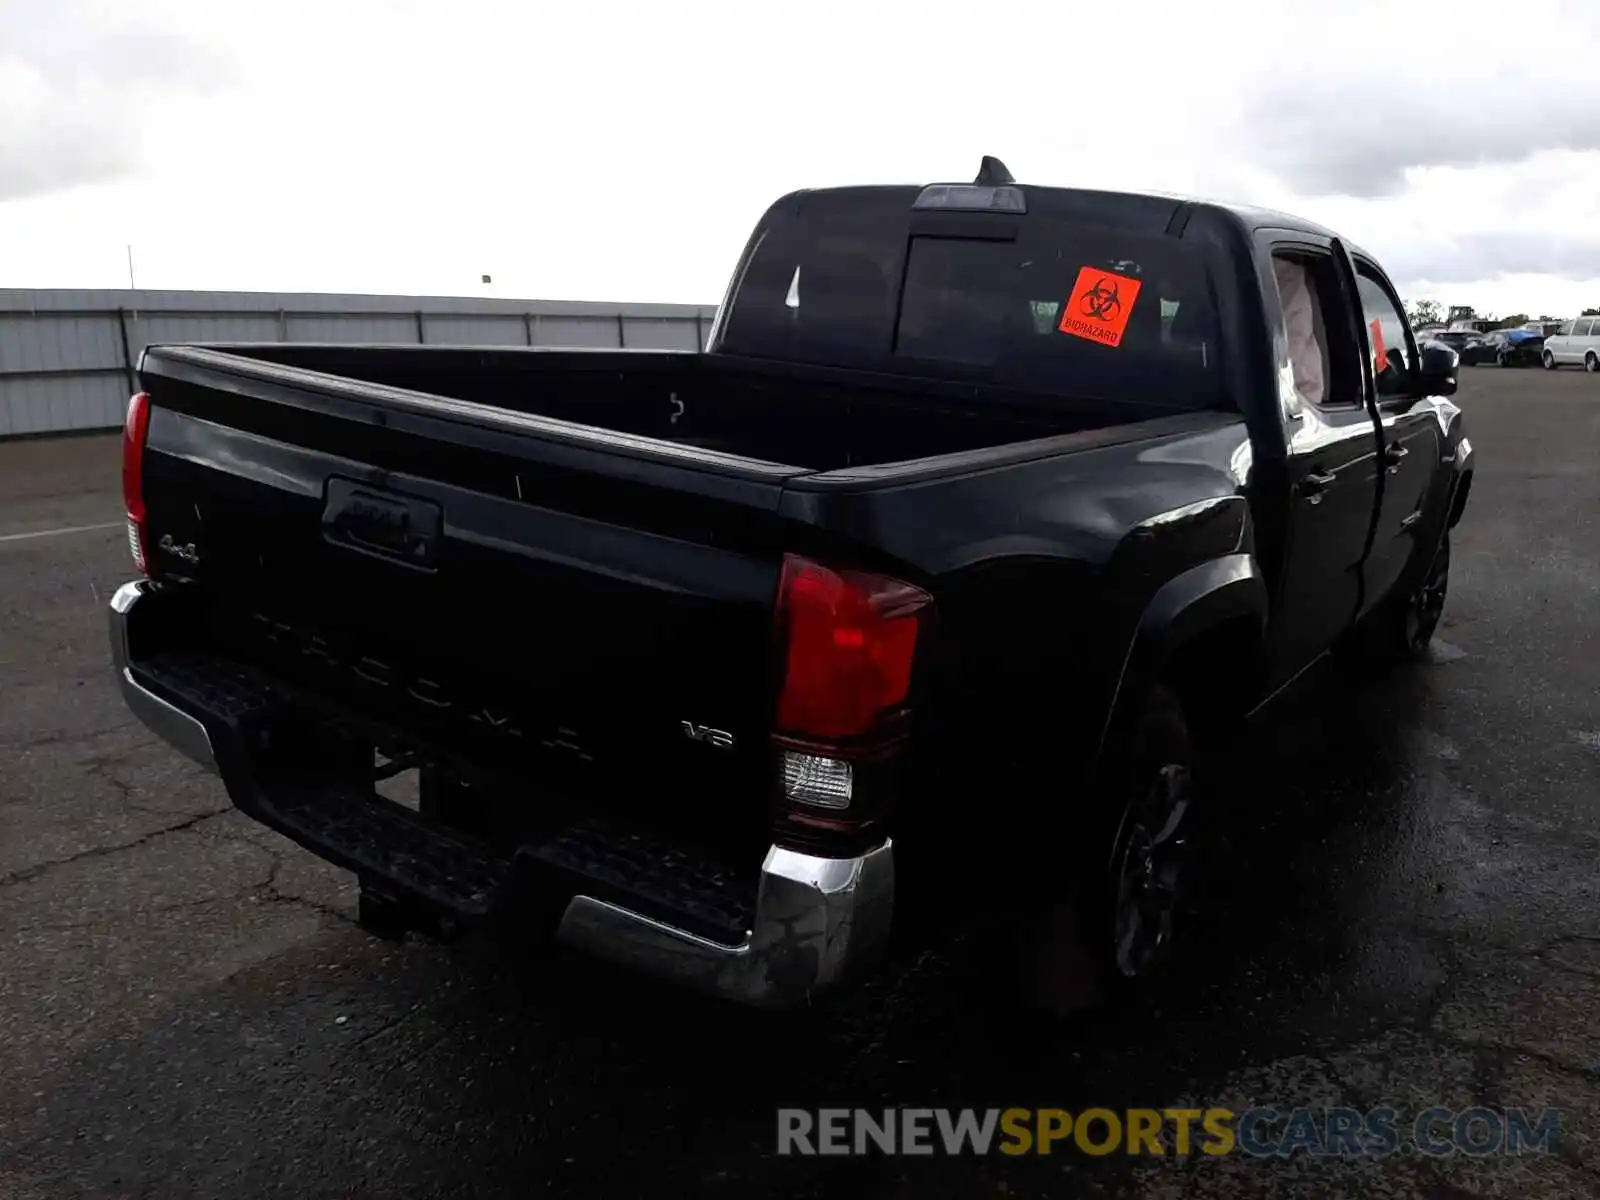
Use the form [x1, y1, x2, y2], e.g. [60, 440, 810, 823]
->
[1272, 250, 1362, 408]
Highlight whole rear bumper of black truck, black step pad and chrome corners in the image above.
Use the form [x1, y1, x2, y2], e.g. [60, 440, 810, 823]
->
[110, 581, 894, 1006]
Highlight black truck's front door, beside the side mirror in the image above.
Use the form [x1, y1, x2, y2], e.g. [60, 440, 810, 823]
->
[1354, 256, 1443, 620]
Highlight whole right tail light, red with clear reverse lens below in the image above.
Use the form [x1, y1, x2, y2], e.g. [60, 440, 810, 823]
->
[773, 555, 933, 826]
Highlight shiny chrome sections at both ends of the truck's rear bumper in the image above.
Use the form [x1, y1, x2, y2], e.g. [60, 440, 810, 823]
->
[110, 579, 894, 1008]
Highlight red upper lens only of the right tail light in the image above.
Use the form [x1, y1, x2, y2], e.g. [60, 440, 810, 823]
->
[776, 555, 933, 742]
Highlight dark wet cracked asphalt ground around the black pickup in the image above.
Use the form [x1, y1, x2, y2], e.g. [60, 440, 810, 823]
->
[0, 368, 1600, 1200]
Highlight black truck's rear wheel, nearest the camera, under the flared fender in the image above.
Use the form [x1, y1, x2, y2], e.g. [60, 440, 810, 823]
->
[1013, 685, 1194, 1019]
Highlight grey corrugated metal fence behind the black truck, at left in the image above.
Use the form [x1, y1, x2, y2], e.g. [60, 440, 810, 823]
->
[0, 290, 717, 437]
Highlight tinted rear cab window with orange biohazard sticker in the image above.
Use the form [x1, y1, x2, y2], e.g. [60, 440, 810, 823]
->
[723, 192, 1224, 410]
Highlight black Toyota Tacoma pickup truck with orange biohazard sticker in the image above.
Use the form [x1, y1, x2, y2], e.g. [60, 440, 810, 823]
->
[110, 160, 1474, 1005]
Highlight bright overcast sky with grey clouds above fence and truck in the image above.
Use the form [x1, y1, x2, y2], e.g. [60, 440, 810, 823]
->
[0, 0, 1600, 314]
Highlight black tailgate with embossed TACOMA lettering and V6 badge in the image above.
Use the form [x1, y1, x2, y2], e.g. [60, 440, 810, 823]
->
[141, 350, 802, 837]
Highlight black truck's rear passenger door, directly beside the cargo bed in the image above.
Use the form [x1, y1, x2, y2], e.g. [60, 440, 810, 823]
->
[1264, 234, 1379, 683]
